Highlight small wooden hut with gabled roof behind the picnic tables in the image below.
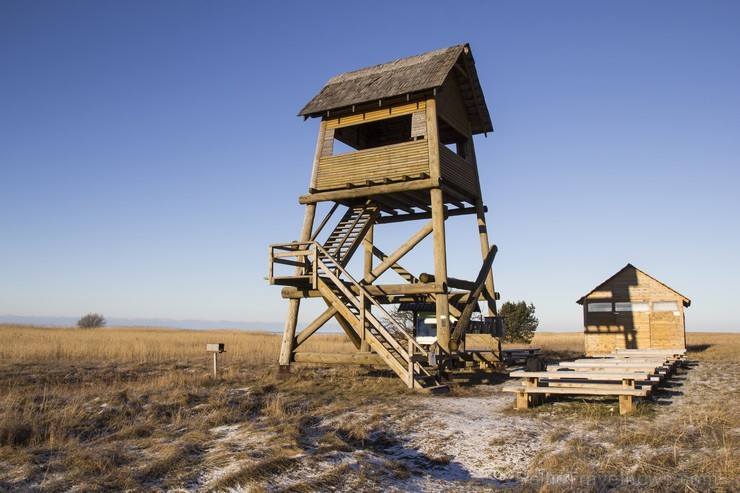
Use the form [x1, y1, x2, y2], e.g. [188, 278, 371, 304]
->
[577, 264, 691, 356]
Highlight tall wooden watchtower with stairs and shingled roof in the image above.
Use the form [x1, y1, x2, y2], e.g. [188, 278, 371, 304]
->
[269, 44, 502, 387]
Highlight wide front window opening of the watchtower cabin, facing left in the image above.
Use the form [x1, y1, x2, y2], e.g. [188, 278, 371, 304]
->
[332, 115, 411, 155]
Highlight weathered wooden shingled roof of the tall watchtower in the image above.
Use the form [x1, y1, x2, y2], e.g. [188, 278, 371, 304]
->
[298, 44, 493, 134]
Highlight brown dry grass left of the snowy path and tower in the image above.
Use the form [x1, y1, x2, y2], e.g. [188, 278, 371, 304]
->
[0, 325, 405, 491]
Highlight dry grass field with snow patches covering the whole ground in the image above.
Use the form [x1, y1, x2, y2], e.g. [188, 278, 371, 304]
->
[0, 325, 740, 492]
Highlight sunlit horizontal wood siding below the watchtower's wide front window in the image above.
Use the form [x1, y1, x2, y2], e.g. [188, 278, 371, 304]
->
[316, 140, 429, 191]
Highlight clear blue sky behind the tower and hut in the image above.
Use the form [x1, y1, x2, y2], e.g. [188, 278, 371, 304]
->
[0, 0, 740, 331]
